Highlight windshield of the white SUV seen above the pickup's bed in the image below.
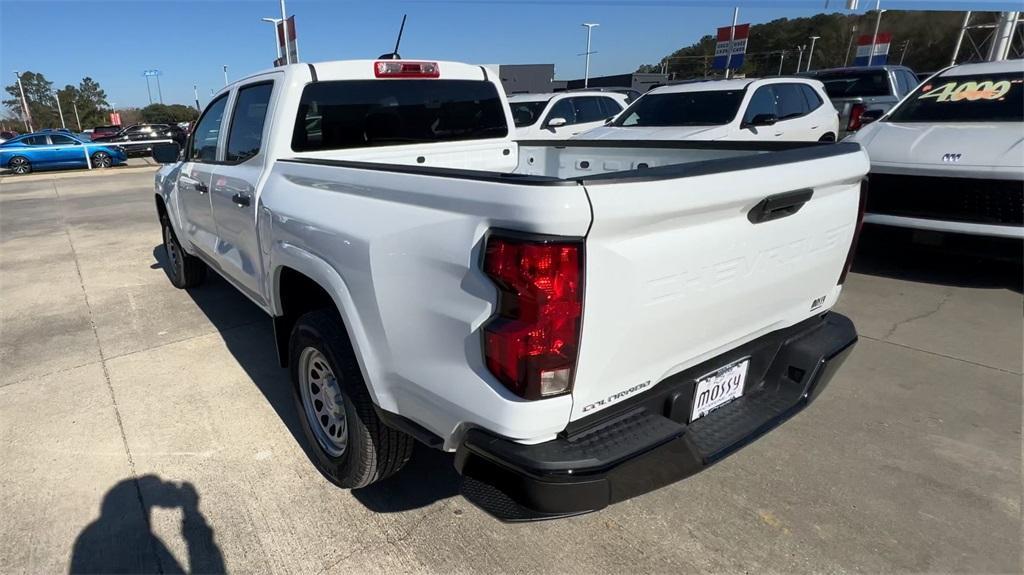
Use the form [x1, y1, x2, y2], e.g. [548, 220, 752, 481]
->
[612, 90, 743, 126]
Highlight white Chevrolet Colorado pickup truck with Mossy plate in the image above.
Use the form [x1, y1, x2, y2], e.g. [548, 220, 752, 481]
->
[154, 60, 868, 520]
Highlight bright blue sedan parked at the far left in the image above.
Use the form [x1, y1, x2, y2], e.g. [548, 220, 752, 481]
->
[0, 132, 128, 174]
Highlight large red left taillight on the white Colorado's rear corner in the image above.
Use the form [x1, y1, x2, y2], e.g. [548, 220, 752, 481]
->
[483, 231, 584, 399]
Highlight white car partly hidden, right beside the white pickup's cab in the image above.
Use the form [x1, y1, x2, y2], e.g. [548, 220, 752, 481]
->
[508, 91, 626, 140]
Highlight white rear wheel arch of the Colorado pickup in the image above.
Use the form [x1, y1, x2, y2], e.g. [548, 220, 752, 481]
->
[270, 246, 395, 410]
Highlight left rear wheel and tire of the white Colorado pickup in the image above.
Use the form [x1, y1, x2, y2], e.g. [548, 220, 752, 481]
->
[288, 309, 414, 489]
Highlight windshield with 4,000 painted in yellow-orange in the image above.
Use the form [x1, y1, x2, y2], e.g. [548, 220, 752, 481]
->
[888, 72, 1024, 122]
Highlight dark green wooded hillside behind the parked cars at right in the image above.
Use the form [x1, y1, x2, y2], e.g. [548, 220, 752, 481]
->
[637, 10, 996, 79]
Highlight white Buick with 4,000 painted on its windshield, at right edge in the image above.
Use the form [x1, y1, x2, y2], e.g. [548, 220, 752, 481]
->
[851, 59, 1024, 241]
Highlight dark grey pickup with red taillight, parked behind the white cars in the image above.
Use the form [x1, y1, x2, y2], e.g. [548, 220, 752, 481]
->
[806, 65, 919, 139]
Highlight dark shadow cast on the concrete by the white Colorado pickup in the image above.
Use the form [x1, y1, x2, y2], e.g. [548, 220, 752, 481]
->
[153, 245, 461, 513]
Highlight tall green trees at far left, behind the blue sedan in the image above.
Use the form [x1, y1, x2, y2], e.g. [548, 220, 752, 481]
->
[3, 72, 110, 130]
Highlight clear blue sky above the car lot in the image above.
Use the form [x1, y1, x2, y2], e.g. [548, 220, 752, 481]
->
[0, 0, 1020, 107]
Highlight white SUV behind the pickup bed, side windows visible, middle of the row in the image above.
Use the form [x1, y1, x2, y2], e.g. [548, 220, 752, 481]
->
[577, 78, 839, 141]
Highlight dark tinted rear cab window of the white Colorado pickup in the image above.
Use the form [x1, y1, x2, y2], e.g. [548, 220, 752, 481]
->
[292, 79, 509, 151]
